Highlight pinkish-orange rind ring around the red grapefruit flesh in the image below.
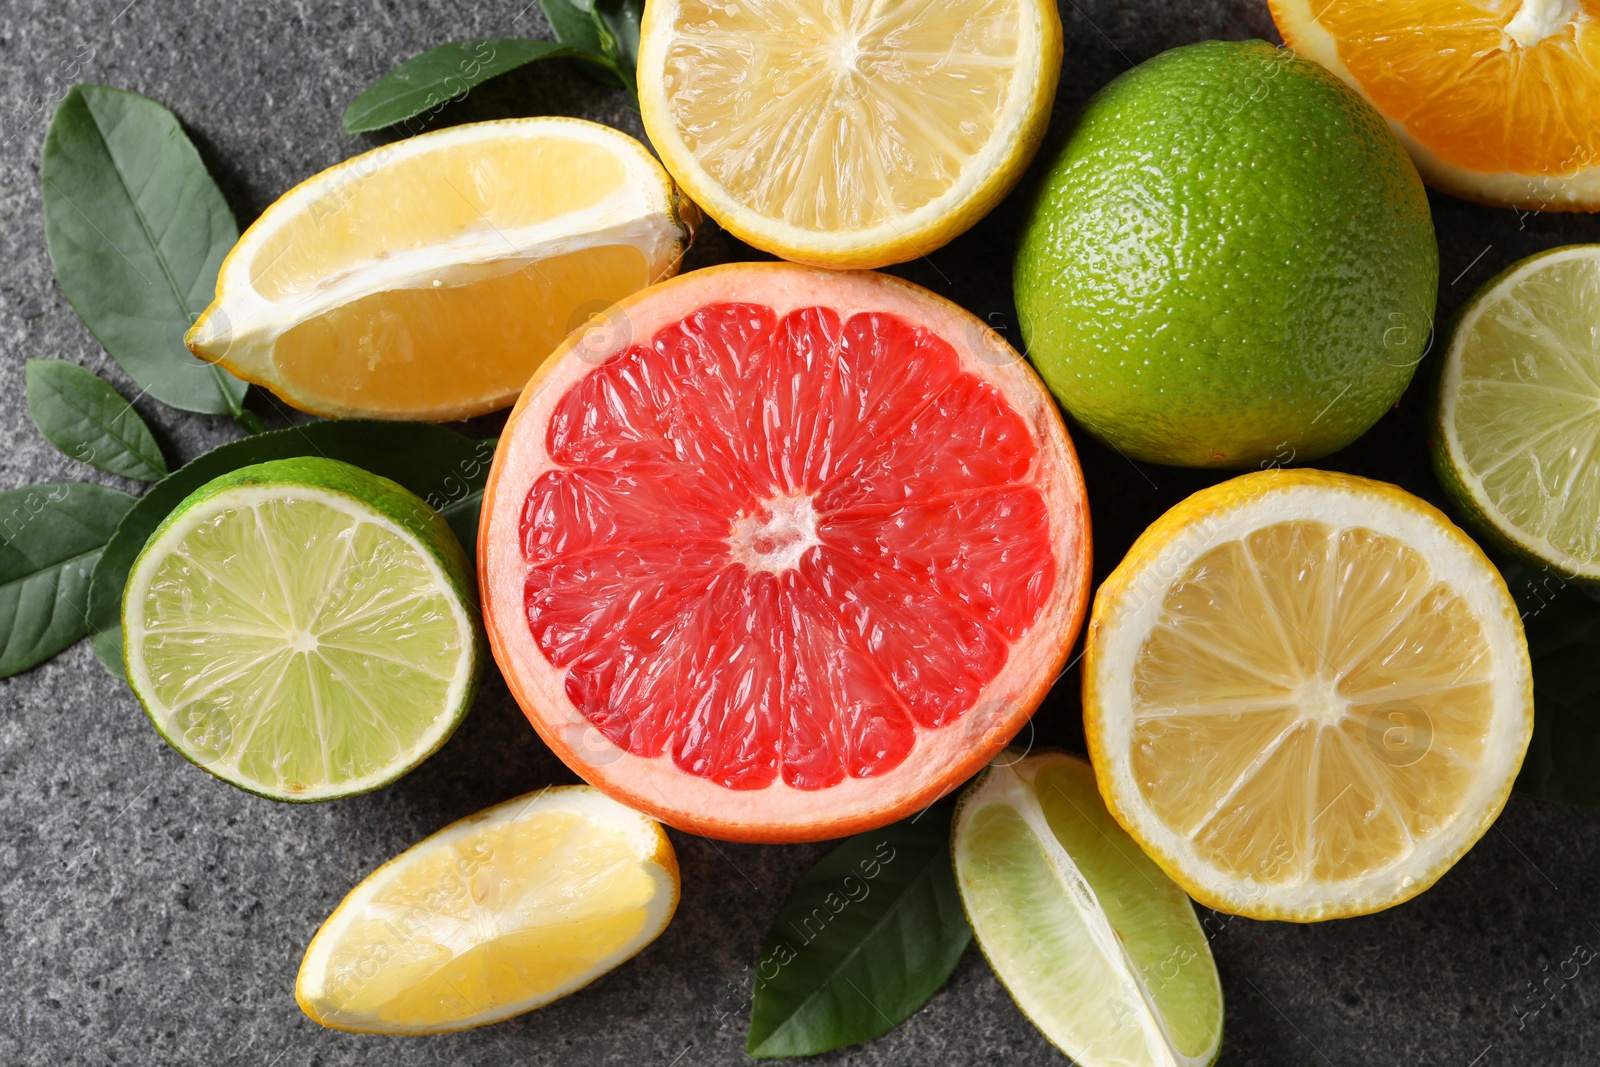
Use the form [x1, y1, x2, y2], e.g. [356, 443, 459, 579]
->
[478, 264, 1090, 843]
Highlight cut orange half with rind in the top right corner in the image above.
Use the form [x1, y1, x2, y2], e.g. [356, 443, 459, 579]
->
[1269, 0, 1600, 211]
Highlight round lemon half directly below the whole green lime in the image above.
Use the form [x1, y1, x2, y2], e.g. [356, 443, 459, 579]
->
[1083, 470, 1533, 921]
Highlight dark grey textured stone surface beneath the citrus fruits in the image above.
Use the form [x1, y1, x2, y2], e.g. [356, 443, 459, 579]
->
[0, 0, 1600, 1067]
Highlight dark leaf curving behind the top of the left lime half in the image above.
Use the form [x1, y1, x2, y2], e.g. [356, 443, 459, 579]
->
[88, 419, 494, 677]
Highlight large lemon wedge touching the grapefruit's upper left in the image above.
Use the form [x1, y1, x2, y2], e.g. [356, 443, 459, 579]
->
[186, 118, 694, 421]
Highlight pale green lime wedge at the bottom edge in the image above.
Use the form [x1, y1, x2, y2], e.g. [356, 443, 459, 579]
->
[954, 752, 1222, 1067]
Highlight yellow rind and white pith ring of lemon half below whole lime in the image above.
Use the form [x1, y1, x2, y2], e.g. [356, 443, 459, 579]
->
[1083, 469, 1533, 923]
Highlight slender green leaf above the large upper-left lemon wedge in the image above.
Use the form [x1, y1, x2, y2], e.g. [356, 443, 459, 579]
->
[344, 38, 573, 133]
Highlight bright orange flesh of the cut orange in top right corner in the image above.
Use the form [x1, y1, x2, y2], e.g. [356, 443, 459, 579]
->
[1312, 0, 1600, 174]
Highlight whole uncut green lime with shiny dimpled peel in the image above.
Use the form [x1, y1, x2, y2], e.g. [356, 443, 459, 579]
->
[1016, 42, 1438, 467]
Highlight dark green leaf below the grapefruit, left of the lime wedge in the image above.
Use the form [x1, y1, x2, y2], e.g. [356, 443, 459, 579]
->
[746, 805, 973, 1057]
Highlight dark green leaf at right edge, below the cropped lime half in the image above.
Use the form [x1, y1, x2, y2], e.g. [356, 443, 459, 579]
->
[1501, 563, 1600, 806]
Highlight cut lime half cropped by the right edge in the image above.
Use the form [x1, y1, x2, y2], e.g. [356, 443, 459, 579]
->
[1434, 245, 1600, 581]
